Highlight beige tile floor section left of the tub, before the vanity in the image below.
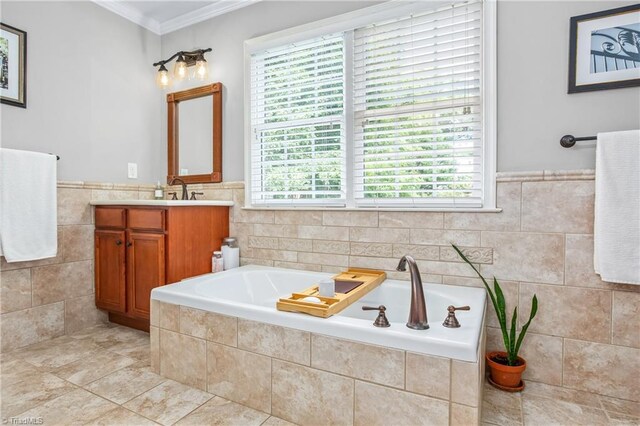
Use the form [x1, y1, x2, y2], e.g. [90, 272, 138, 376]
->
[0, 325, 290, 426]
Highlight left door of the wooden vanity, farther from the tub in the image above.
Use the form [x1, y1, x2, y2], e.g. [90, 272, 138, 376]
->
[95, 230, 127, 313]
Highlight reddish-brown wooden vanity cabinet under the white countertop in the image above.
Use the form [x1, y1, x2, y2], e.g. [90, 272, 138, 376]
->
[95, 206, 229, 330]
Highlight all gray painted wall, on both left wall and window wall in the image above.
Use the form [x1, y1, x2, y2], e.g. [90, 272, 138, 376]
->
[1, 1, 640, 183]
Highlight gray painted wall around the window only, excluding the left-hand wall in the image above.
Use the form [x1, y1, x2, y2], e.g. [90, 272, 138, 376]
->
[162, 1, 640, 180]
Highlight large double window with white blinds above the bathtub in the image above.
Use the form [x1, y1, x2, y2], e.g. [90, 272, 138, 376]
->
[247, 1, 495, 209]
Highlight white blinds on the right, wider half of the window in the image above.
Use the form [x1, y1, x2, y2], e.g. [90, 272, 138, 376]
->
[353, 2, 483, 207]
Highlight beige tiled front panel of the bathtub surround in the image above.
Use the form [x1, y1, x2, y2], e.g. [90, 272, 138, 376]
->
[151, 300, 484, 425]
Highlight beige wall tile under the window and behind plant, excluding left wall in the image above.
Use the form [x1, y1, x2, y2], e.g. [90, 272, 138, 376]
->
[176, 170, 640, 402]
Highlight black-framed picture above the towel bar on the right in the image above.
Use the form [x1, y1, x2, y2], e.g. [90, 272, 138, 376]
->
[569, 4, 640, 93]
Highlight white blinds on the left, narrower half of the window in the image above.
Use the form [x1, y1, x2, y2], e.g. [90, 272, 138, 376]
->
[250, 34, 346, 206]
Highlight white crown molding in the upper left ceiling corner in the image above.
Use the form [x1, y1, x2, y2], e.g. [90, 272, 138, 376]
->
[91, 0, 261, 35]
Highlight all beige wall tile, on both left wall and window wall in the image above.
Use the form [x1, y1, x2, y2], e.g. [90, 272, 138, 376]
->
[0, 171, 640, 401]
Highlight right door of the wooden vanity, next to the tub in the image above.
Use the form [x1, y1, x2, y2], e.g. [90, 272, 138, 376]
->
[127, 231, 165, 319]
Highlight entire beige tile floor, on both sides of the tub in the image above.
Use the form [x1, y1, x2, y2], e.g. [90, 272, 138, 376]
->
[0, 324, 640, 426]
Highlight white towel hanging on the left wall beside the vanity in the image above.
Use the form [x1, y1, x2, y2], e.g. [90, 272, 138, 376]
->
[0, 148, 58, 262]
